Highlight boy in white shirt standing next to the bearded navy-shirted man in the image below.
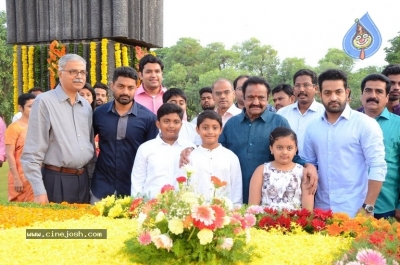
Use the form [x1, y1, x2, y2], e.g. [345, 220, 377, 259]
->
[131, 103, 195, 198]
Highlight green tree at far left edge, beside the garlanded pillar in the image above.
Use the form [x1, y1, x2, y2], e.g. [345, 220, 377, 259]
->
[0, 11, 14, 124]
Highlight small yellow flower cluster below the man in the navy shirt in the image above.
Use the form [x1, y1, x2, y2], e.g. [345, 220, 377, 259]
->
[95, 194, 132, 218]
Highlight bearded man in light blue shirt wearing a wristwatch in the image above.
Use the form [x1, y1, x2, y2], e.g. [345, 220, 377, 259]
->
[303, 69, 386, 217]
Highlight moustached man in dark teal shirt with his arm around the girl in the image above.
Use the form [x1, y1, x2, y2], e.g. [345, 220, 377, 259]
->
[219, 76, 317, 203]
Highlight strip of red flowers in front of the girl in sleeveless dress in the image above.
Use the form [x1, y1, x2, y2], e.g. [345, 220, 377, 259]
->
[252, 205, 332, 234]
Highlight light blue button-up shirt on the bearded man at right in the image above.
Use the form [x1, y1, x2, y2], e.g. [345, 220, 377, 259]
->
[304, 104, 387, 217]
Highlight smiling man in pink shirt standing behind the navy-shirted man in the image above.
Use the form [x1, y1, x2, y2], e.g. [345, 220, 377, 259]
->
[135, 54, 167, 115]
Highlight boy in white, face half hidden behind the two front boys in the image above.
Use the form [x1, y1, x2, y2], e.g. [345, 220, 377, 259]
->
[163, 88, 201, 145]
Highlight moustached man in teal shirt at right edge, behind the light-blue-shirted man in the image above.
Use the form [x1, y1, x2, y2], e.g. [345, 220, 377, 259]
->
[361, 74, 400, 221]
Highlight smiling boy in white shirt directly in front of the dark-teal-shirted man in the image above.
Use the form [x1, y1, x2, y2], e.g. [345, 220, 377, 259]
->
[189, 110, 243, 204]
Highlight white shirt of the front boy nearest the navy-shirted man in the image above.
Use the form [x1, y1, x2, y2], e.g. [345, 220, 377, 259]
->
[131, 135, 196, 198]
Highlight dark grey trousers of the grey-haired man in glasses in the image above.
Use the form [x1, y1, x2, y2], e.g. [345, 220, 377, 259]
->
[42, 168, 90, 203]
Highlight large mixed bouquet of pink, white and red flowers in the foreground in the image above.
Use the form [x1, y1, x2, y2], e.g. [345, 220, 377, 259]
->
[126, 177, 256, 264]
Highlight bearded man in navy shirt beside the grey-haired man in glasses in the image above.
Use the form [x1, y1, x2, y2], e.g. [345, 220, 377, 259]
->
[90, 67, 158, 204]
